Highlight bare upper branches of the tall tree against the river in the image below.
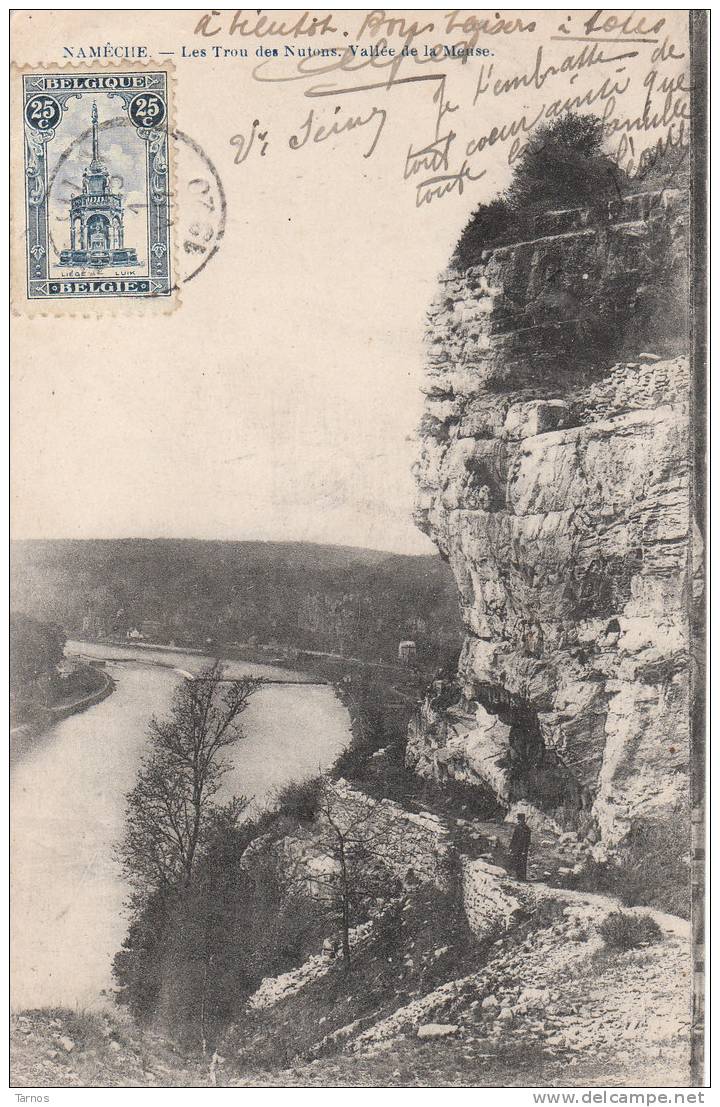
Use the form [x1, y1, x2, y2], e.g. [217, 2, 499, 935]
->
[119, 661, 261, 899]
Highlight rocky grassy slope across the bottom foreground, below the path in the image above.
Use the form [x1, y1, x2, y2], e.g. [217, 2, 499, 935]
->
[11, 891, 689, 1087]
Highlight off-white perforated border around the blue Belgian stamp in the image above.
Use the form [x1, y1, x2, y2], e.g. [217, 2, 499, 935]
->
[10, 58, 181, 319]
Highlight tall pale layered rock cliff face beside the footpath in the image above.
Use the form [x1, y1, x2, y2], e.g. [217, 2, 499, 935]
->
[408, 190, 700, 845]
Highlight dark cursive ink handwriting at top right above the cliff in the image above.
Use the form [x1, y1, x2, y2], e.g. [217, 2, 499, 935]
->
[212, 8, 690, 208]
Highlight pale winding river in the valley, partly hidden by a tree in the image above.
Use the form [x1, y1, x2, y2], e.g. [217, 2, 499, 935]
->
[10, 642, 350, 1010]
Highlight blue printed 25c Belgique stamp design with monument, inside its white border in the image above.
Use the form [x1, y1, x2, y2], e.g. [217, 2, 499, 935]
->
[22, 69, 173, 301]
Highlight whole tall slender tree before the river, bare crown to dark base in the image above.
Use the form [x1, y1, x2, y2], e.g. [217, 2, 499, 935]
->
[113, 662, 261, 1052]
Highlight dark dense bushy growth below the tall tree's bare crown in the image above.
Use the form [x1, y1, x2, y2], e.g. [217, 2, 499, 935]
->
[113, 808, 325, 1053]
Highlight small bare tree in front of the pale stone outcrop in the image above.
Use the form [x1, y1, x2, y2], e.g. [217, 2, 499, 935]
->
[288, 777, 400, 972]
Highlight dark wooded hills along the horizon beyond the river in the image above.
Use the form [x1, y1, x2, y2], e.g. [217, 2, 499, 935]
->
[11, 538, 461, 664]
